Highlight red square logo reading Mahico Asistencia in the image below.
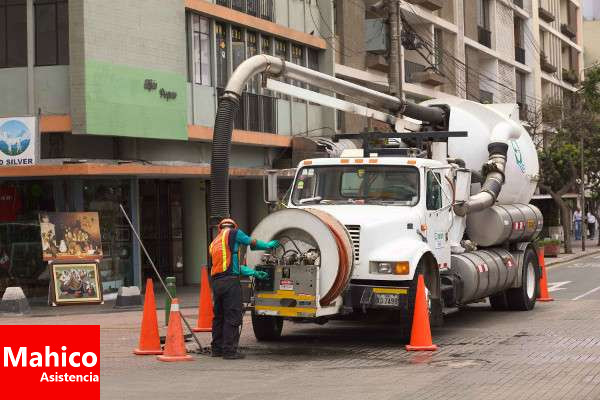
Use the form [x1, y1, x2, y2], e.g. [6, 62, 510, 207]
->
[0, 325, 100, 400]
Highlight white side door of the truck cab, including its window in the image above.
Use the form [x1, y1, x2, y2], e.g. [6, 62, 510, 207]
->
[425, 169, 452, 269]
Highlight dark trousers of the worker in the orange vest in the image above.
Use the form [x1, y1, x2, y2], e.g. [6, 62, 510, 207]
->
[212, 276, 242, 354]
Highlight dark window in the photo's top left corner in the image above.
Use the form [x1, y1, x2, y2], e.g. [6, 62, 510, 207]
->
[0, 0, 27, 68]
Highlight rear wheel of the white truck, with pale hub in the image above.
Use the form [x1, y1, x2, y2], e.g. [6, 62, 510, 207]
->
[506, 249, 540, 311]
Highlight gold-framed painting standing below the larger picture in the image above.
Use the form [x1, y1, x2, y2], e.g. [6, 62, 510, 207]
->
[49, 262, 102, 305]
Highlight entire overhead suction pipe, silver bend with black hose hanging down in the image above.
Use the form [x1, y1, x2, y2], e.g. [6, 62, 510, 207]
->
[211, 55, 446, 220]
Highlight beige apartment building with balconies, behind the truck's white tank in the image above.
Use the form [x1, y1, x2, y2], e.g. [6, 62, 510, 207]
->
[335, 0, 583, 131]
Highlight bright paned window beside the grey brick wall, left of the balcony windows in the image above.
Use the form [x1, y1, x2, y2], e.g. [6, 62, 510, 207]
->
[192, 14, 212, 86]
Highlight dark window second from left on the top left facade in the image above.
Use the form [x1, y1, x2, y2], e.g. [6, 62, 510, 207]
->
[34, 0, 69, 65]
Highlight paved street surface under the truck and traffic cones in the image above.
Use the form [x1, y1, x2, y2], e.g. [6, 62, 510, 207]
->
[2, 255, 600, 400]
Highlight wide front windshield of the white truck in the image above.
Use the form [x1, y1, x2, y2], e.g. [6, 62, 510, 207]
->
[291, 165, 419, 206]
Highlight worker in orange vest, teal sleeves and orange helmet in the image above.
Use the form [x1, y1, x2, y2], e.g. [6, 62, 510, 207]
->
[208, 218, 279, 360]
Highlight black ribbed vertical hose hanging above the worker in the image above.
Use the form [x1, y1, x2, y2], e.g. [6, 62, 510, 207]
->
[210, 93, 239, 225]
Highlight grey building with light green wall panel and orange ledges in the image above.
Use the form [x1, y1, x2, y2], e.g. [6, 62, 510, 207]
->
[0, 0, 335, 297]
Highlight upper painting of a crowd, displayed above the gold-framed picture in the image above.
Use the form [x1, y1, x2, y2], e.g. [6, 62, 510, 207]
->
[39, 212, 103, 261]
